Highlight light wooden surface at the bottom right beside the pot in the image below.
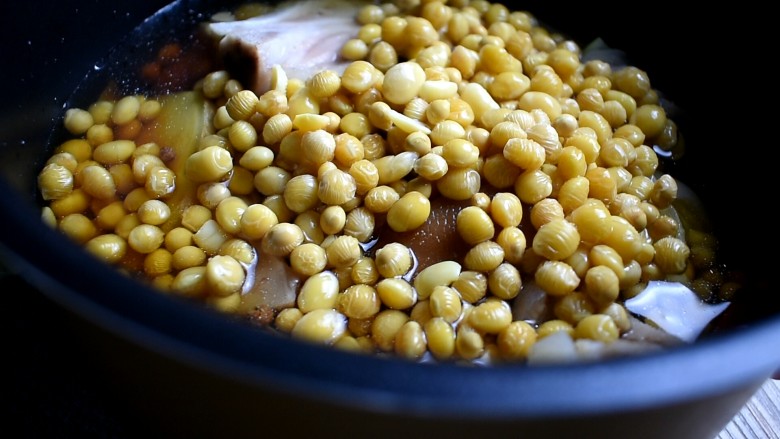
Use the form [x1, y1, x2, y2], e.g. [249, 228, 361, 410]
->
[715, 380, 780, 439]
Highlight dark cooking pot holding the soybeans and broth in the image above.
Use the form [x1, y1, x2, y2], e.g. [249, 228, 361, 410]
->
[0, 0, 780, 439]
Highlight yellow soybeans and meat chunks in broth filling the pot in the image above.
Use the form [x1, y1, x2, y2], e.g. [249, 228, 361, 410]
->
[33, 0, 739, 364]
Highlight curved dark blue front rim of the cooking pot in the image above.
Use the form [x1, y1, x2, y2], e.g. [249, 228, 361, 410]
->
[0, 184, 780, 418]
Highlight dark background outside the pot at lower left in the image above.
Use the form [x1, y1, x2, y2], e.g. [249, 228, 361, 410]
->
[0, 272, 154, 438]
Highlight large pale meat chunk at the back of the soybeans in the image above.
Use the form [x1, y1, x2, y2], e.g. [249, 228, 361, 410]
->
[208, 0, 363, 95]
